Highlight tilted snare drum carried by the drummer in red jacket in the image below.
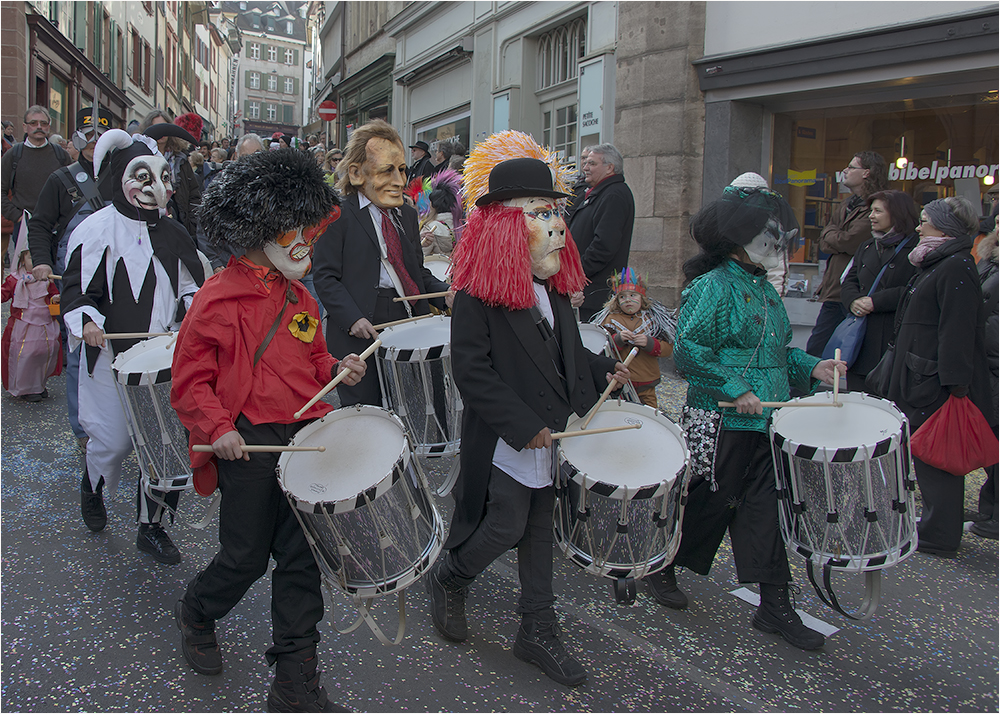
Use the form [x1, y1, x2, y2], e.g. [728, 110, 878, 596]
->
[277, 404, 444, 600]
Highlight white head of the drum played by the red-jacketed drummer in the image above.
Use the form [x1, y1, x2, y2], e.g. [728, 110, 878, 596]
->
[278, 407, 408, 510]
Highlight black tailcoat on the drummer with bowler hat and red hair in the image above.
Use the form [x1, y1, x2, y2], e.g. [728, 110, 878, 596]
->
[445, 292, 615, 548]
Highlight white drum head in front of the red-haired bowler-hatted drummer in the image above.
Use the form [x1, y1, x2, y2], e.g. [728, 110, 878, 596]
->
[559, 402, 688, 498]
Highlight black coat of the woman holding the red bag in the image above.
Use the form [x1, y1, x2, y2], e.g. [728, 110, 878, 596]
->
[889, 237, 997, 431]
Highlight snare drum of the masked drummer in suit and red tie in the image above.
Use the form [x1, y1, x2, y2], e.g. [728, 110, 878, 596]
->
[376, 315, 462, 456]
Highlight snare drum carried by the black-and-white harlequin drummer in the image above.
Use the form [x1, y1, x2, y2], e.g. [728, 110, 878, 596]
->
[111, 336, 193, 493]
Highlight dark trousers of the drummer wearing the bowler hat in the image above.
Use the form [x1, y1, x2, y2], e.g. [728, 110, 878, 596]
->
[445, 466, 556, 619]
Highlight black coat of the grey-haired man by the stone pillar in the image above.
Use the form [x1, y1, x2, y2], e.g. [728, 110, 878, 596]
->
[569, 176, 635, 312]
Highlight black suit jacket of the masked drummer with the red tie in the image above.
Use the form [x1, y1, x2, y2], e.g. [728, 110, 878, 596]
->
[313, 189, 449, 405]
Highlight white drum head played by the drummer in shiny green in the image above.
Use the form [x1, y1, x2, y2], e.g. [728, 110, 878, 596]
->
[771, 392, 903, 451]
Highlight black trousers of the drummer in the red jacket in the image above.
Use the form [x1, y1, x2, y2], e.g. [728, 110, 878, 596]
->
[184, 415, 323, 664]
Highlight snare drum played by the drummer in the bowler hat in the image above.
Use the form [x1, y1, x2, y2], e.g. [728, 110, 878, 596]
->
[554, 402, 689, 580]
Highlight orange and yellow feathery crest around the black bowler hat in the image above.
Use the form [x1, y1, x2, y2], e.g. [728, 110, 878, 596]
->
[462, 129, 573, 213]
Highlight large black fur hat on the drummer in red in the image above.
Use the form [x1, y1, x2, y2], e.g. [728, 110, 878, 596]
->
[198, 149, 340, 249]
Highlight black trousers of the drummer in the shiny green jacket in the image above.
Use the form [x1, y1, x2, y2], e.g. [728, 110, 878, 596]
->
[674, 430, 792, 585]
